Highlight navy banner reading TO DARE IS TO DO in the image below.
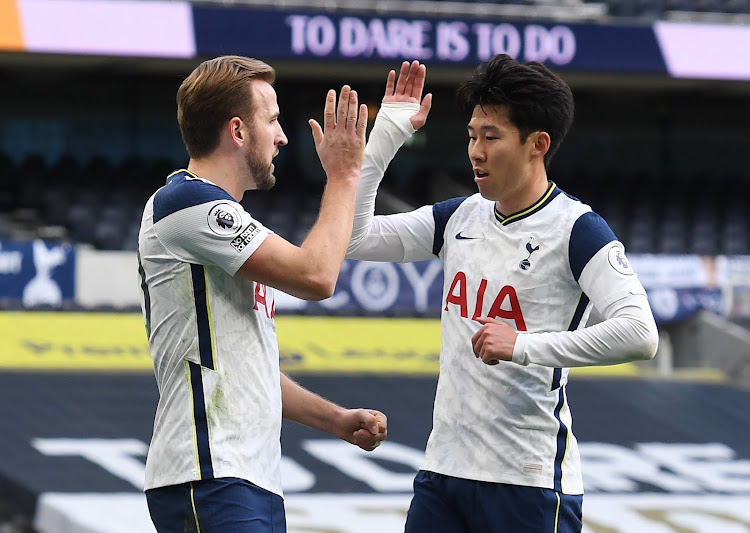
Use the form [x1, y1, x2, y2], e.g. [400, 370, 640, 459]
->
[193, 5, 667, 73]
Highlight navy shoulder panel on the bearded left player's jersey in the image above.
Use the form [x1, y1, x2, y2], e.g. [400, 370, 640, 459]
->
[154, 170, 235, 224]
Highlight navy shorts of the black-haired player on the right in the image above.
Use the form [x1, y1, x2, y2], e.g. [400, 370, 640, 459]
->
[406, 470, 583, 533]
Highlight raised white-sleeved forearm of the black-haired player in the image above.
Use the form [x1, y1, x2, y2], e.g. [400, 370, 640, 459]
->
[349, 103, 419, 252]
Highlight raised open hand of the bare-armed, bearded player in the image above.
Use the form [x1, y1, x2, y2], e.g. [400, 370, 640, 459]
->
[309, 85, 367, 179]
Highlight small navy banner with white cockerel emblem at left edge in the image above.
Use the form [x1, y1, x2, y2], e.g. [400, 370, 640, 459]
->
[0, 240, 75, 307]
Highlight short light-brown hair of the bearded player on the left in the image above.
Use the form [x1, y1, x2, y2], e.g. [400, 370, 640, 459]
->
[177, 56, 276, 158]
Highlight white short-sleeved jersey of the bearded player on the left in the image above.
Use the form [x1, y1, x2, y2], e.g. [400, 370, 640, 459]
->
[138, 170, 281, 495]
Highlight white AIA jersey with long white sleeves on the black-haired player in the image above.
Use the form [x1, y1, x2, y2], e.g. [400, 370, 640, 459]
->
[347, 104, 656, 494]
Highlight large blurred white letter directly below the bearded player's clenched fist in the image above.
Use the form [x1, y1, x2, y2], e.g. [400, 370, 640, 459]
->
[302, 439, 424, 492]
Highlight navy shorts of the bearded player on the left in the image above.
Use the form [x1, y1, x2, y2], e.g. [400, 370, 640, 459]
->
[146, 478, 286, 533]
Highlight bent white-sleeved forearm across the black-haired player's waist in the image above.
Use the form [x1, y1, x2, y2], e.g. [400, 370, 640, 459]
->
[513, 295, 659, 367]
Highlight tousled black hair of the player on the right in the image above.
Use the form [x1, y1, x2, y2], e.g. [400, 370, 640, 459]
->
[456, 54, 575, 167]
